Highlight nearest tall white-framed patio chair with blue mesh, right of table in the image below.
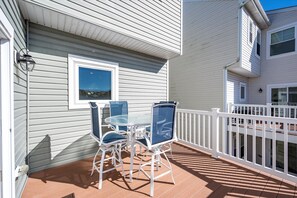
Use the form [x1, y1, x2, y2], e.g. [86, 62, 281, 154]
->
[137, 102, 177, 196]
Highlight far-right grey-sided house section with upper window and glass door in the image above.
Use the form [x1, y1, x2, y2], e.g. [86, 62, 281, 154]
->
[248, 7, 297, 105]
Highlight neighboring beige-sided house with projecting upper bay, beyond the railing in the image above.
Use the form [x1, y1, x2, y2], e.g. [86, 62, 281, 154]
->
[169, 0, 270, 110]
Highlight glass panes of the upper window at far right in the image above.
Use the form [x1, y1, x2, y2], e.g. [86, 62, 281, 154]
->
[270, 27, 295, 56]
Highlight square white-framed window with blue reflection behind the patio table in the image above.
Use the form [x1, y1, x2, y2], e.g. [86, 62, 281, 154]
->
[68, 55, 118, 109]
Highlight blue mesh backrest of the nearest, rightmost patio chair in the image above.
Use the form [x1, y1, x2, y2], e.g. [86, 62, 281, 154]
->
[151, 102, 176, 145]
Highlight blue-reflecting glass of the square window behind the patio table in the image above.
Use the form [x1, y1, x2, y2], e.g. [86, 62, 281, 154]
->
[79, 66, 112, 100]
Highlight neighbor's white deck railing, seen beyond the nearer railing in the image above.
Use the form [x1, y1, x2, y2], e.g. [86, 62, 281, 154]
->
[228, 103, 297, 118]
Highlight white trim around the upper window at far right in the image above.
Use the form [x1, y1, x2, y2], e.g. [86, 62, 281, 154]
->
[266, 23, 297, 59]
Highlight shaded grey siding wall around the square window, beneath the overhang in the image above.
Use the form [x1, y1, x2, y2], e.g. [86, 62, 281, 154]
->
[29, 23, 167, 172]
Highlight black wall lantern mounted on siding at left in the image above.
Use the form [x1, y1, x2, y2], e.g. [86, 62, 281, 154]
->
[16, 48, 36, 72]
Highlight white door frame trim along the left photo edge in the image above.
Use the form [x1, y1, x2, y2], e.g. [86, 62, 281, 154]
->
[0, 8, 15, 198]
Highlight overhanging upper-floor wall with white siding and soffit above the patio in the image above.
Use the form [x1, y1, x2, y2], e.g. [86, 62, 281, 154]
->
[20, 0, 181, 58]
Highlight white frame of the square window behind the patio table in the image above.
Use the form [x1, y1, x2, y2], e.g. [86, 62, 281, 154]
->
[68, 54, 119, 109]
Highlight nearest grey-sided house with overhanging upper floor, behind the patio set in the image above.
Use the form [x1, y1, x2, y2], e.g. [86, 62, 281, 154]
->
[0, 0, 182, 197]
